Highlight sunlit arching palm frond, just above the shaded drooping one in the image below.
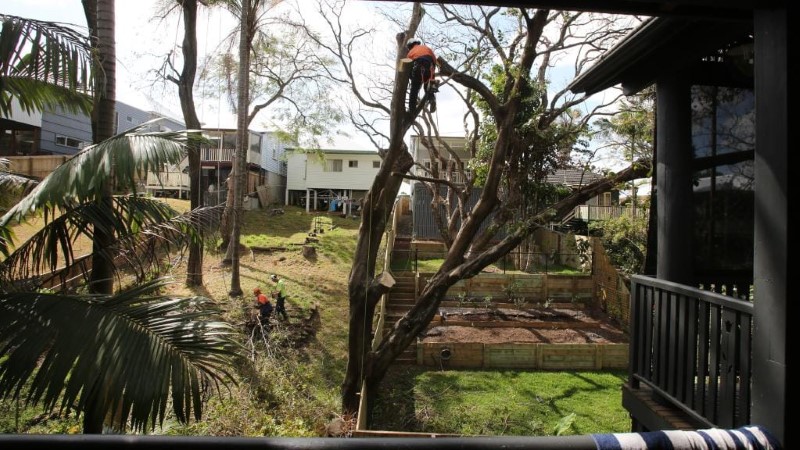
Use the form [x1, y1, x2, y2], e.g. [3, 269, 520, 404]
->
[0, 119, 206, 226]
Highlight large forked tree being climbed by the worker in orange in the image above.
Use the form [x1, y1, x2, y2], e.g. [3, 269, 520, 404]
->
[300, 3, 647, 414]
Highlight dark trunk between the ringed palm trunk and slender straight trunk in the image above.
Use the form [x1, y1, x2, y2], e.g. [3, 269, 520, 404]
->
[178, 0, 203, 286]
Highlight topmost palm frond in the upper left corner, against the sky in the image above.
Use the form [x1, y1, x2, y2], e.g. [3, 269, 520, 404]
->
[0, 14, 92, 116]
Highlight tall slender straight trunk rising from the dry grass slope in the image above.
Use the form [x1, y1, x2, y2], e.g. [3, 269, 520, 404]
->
[228, 0, 251, 297]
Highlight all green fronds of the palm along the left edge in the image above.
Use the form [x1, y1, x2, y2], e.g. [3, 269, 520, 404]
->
[0, 11, 244, 433]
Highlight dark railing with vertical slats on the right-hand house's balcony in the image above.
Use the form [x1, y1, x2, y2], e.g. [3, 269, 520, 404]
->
[629, 275, 753, 427]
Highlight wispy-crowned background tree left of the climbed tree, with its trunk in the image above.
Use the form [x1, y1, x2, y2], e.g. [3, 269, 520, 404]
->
[200, 0, 340, 296]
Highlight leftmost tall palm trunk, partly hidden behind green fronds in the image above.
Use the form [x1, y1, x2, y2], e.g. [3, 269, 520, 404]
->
[83, 0, 117, 434]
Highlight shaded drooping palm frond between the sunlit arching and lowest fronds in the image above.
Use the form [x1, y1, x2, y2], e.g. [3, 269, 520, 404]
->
[0, 196, 222, 290]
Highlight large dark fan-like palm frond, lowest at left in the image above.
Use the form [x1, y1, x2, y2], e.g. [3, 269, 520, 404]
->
[0, 280, 241, 430]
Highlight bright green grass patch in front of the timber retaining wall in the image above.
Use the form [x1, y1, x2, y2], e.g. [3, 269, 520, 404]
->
[372, 367, 630, 436]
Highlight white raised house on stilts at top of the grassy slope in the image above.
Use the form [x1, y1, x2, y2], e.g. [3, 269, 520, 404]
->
[286, 148, 381, 215]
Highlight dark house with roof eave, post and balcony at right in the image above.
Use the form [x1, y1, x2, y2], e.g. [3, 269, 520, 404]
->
[569, 7, 798, 448]
